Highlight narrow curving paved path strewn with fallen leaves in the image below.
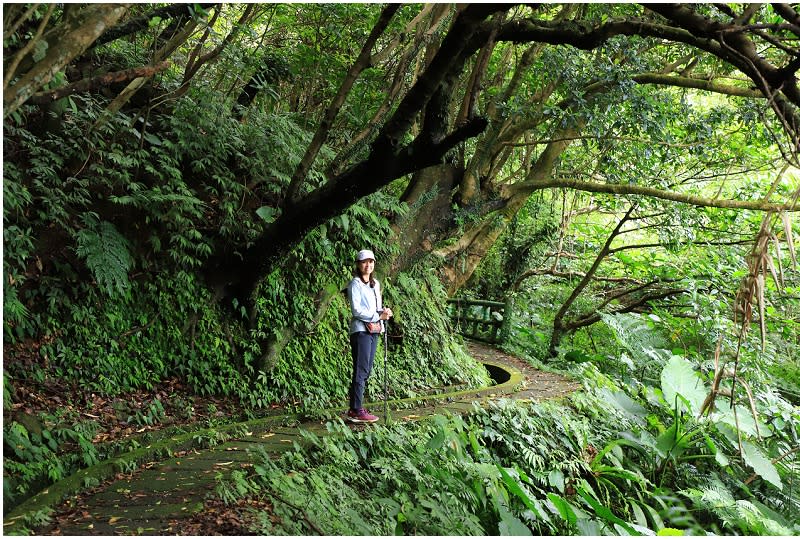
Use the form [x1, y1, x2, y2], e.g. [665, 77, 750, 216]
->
[3, 342, 580, 535]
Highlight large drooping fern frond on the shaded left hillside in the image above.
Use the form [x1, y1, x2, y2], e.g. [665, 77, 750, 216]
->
[75, 221, 133, 296]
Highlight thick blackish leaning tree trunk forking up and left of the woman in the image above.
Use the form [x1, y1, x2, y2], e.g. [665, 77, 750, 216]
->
[209, 4, 506, 301]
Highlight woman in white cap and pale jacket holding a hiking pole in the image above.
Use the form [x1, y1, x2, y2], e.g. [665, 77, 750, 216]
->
[347, 249, 392, 423]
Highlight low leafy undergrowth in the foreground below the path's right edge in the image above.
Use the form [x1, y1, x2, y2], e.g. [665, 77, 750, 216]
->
[216, 380, 800, 535]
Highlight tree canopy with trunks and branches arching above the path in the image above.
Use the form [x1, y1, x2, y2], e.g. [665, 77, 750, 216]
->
[4, 4, 800, 296]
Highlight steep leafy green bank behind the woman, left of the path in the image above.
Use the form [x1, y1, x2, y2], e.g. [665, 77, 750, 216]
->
[3, 4, 486, 506]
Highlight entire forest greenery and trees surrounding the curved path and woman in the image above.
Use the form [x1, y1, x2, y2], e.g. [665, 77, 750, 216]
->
[3, 3, 800, 535]
